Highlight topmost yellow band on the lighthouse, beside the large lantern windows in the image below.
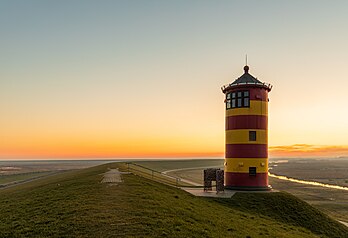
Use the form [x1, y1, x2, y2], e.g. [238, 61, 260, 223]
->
[226, 100, 268, 117]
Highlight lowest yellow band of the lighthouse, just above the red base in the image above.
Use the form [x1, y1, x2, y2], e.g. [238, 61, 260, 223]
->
[225, 158, 268, 173]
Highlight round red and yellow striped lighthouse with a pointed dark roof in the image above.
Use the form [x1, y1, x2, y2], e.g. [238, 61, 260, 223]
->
[222, 66, 272, 190]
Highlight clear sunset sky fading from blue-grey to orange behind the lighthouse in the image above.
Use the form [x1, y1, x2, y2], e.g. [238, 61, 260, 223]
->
[0, 0, 348, 159]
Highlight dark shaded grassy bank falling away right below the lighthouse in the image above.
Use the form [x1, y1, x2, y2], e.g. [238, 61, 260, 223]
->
[216, 192, 348, 237]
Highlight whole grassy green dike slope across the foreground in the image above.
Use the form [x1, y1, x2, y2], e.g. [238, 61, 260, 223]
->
[0, 163, 348, 237]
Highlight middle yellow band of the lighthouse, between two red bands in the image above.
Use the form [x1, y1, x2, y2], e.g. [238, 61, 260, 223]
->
[226, 129, 268, 144]
